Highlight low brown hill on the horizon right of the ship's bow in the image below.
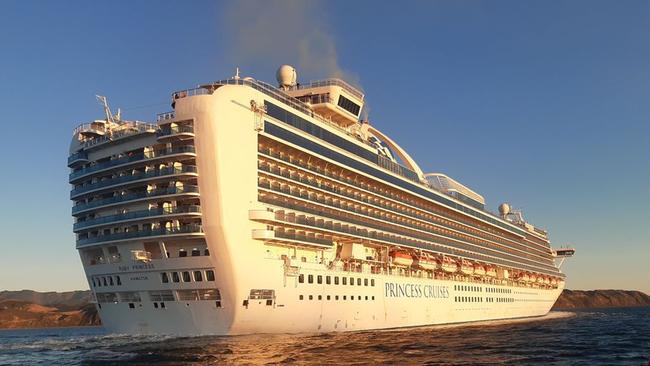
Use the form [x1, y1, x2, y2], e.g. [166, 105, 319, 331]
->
[553, 290, 650, 309]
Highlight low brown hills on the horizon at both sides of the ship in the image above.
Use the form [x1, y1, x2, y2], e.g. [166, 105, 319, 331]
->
[0, 290, 650, 329]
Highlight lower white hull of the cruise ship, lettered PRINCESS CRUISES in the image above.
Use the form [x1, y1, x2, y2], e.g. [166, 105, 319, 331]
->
[92, 259, 562, 335]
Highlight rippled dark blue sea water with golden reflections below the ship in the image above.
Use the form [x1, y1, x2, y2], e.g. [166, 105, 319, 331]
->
[0, 308, 650, 366]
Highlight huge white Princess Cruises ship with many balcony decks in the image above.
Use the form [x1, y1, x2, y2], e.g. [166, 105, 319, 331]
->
[68, 65, 574, 335]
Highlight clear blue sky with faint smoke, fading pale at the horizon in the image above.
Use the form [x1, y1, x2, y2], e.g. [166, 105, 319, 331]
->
[0, 0, 650, 293]
